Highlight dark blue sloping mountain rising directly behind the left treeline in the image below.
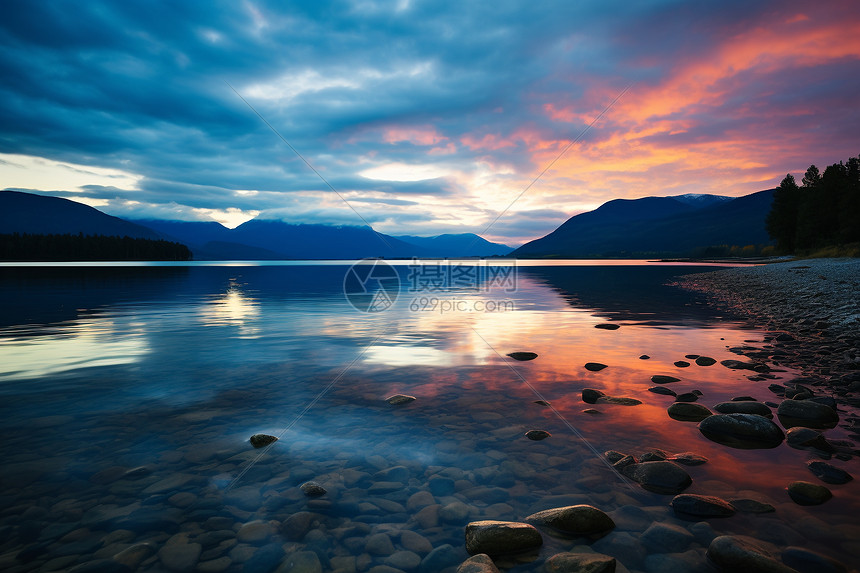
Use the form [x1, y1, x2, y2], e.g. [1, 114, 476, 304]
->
[0, 191, 162, 239]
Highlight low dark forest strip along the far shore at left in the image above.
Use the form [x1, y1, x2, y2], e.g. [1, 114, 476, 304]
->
[0, 233, 191, 261]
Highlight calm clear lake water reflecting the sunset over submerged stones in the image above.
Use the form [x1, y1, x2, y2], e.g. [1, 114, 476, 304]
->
[0, 261, 860, 573]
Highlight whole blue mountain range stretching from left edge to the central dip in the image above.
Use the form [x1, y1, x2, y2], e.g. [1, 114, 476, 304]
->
[0, 191, 513, 260]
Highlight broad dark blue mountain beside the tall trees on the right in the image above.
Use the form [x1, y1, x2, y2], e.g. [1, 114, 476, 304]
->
[512, 189, 774, 258]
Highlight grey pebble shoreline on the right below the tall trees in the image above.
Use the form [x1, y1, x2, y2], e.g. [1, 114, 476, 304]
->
[676, 255, 860, 407]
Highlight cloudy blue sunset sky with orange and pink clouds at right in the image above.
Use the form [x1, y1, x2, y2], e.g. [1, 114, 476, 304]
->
[0, 0, 860, 245]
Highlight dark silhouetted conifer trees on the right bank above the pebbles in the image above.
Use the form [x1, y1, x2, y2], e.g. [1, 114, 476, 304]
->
[767, 156, 860, 253]
